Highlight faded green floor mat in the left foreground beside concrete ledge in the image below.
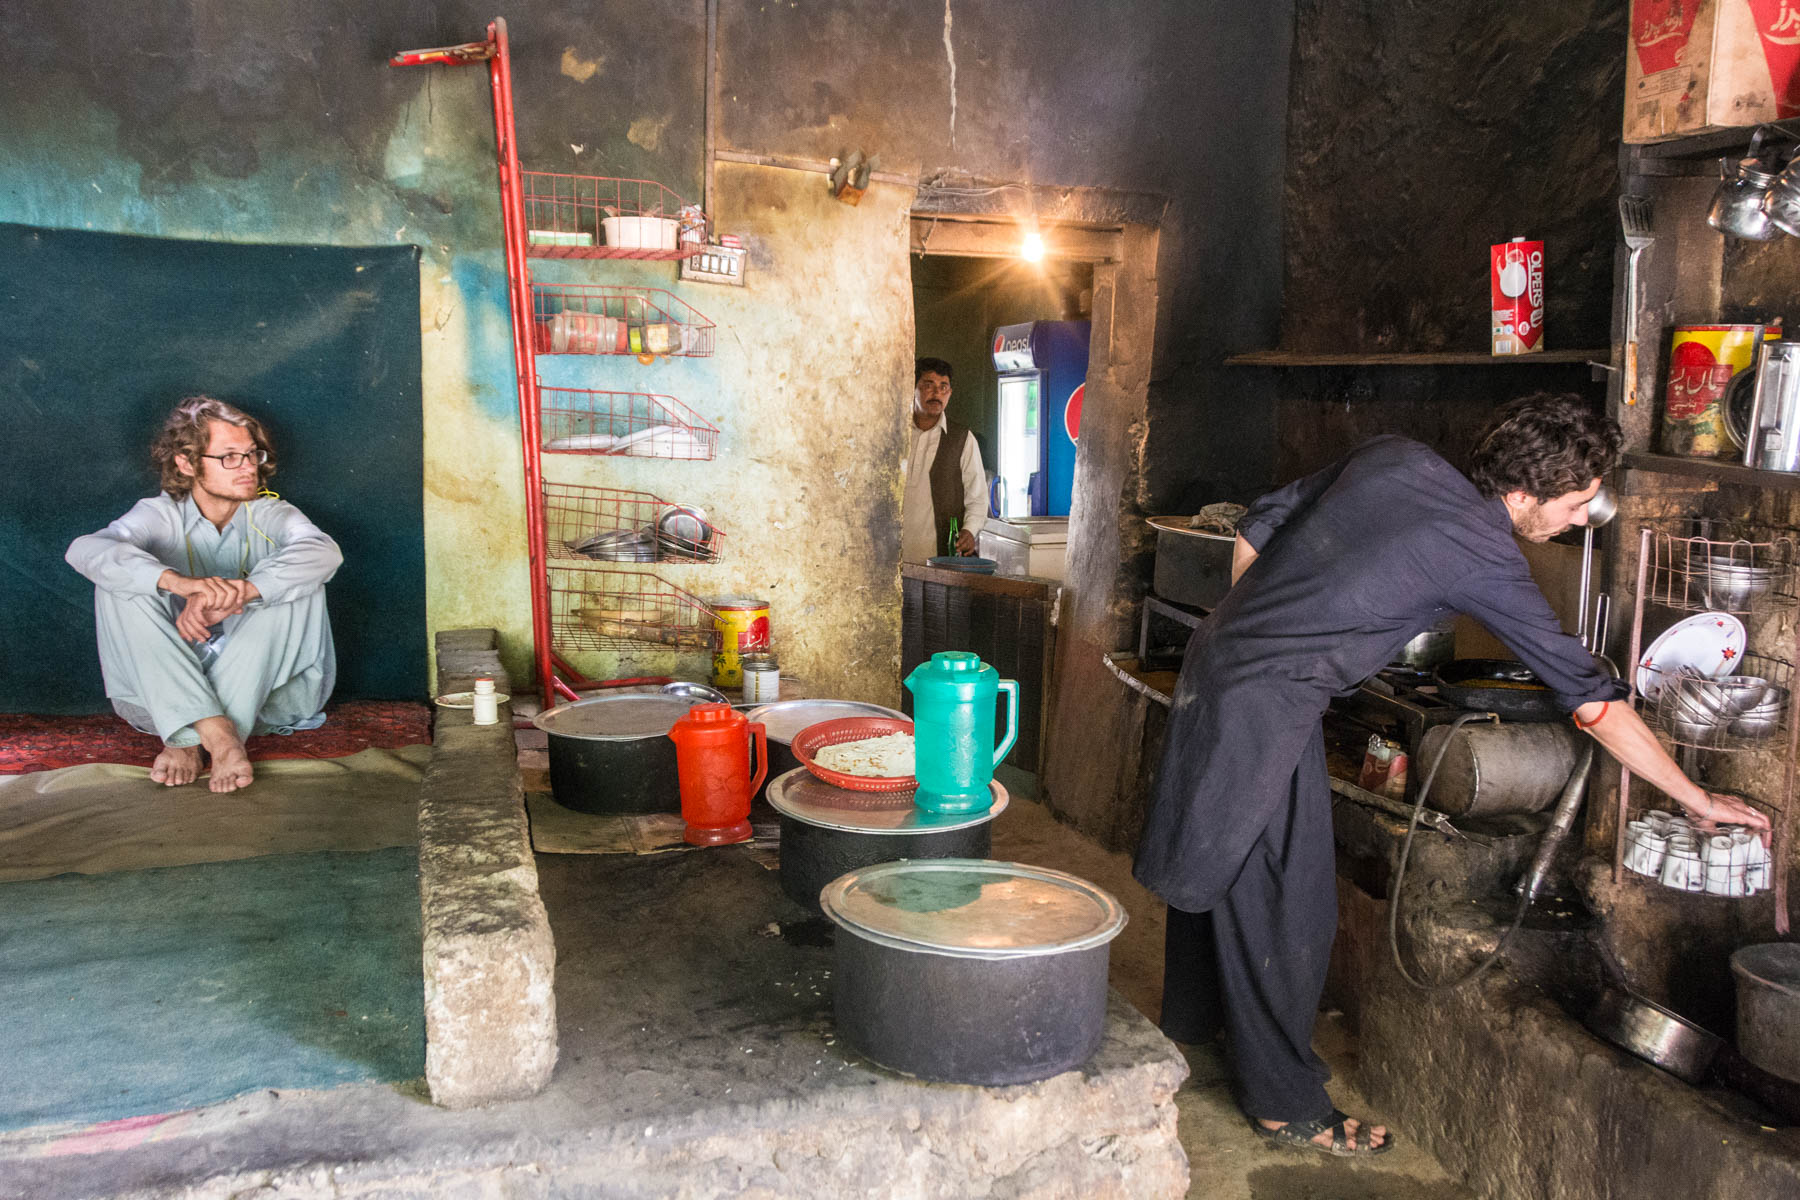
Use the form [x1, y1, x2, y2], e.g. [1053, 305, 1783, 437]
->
[0, 847, 425, 1130]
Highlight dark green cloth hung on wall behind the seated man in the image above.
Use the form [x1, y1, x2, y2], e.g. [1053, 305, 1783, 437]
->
[0, 223, 427, 712]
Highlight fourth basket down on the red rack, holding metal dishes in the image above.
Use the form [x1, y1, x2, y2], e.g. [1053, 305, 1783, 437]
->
[544, 480, 725, 563]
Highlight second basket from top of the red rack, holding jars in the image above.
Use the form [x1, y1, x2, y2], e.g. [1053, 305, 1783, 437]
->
[531, 282, 715, 358]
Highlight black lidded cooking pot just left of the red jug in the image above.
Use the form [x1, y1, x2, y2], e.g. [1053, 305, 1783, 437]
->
[531, 693, 704, 813]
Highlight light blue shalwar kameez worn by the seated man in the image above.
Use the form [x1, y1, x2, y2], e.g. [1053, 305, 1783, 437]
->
[65, 495, 344, 747]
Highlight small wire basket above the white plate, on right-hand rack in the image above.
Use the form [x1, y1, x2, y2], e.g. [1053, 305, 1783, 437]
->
[1645, 522, 1800, 613]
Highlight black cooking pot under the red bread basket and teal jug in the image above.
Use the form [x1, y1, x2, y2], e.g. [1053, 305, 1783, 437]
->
[769, 770, 1006, 912]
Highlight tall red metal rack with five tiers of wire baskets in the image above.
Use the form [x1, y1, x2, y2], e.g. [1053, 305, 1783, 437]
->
[389, 18, 722, 707]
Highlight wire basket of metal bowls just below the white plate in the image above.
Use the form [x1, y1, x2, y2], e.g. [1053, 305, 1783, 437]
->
[1640, 655, 1795, 752]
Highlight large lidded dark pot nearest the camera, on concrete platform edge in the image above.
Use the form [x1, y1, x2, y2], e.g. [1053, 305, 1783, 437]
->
[821, 858, 1125, 1087]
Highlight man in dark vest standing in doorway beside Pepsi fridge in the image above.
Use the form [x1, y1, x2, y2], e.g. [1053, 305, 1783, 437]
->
[900, 358, 988, 563]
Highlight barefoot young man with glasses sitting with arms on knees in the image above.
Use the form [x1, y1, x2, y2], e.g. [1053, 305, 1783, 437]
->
[65, 396, 344, 792]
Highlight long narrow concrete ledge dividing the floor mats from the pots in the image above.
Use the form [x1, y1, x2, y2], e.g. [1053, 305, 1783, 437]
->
[419, 630, 556, 1108]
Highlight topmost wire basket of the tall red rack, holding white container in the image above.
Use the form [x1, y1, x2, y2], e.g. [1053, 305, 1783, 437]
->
[520, 171, 706, 261]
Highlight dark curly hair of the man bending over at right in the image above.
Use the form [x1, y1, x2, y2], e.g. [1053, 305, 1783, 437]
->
[1467, 392, 1624, 502]
